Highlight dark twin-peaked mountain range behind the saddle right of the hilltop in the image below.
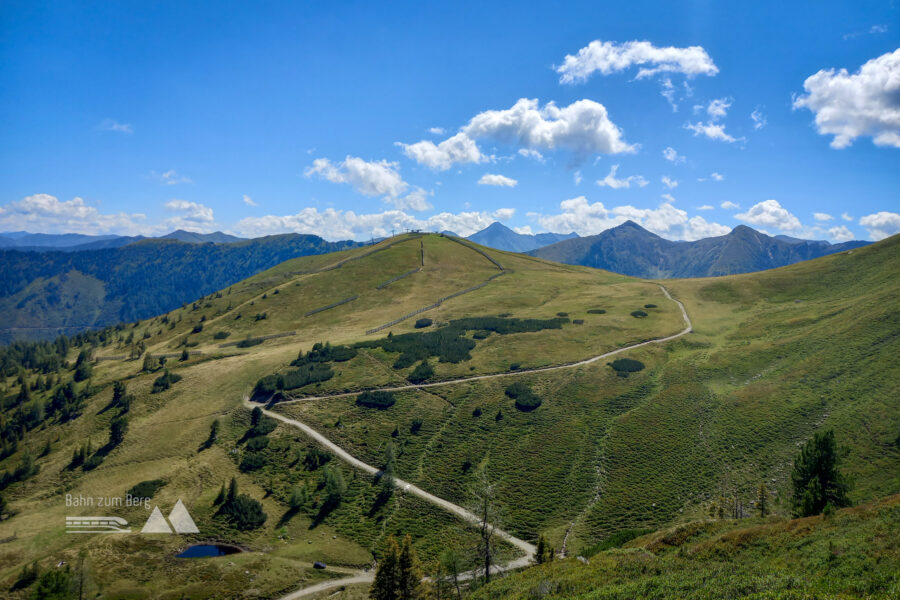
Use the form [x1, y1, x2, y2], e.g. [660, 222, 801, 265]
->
[528, 221, 871, 279]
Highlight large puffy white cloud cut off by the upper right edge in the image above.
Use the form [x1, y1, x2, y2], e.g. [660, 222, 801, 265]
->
[794, 48, 900, 148]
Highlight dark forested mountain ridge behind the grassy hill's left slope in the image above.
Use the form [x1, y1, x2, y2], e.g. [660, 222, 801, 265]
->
[0, 232, 363, 343]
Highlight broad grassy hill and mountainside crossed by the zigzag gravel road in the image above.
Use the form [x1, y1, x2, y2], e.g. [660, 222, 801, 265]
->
[0, 235, 900, 598]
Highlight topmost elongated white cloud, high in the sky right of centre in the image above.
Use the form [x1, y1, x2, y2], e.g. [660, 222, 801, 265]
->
[556, 40, 719, 83]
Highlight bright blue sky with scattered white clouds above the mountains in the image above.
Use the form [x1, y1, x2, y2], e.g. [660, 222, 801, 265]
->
[0, 1, 900, 241]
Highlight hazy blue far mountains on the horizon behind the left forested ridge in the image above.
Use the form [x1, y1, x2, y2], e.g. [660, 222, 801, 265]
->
[0, 229, 245, 252]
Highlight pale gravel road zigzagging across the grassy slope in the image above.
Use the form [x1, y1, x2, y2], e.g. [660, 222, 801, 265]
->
[253, 285, 693, 600]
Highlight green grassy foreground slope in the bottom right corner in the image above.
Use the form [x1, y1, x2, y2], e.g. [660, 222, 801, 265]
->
[471, 496, 900, 600]
